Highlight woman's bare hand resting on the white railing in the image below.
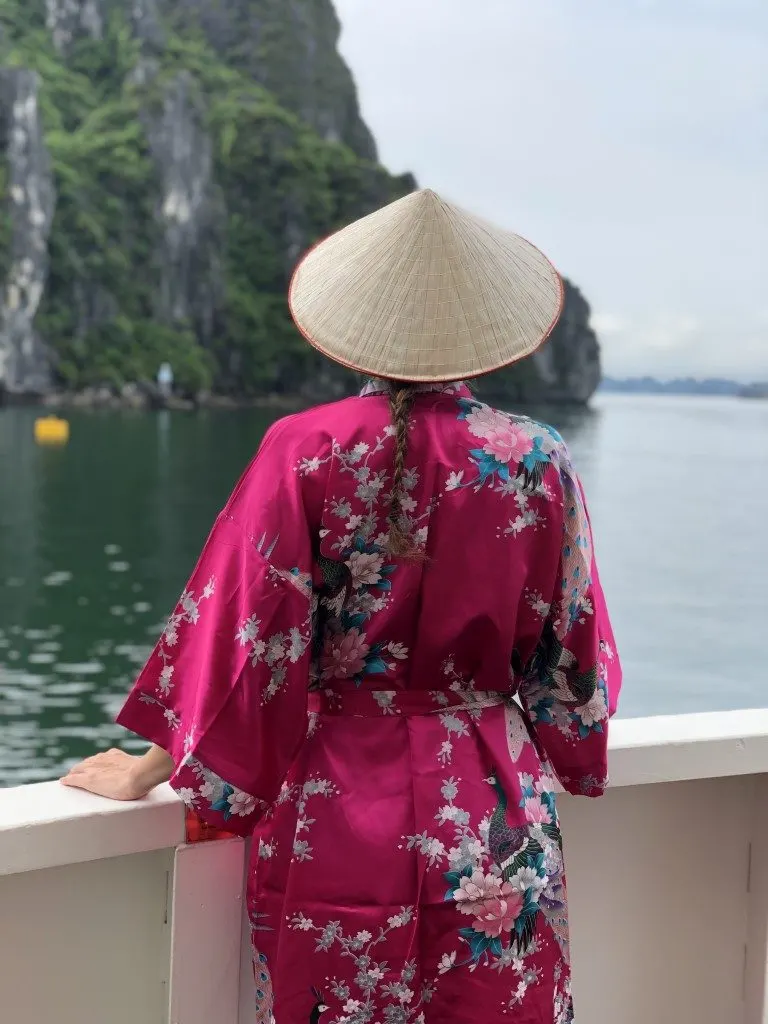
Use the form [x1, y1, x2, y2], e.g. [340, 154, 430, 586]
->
[61, 744, 173, 800]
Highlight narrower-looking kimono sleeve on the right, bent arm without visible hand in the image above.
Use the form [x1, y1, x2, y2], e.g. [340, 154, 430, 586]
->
[519, 445, 622, 797]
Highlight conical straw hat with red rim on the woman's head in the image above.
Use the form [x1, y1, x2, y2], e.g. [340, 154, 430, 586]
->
[289, 189, 563, 381]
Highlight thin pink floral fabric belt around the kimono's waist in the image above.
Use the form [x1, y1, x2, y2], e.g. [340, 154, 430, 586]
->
[308, 689, 513, 718]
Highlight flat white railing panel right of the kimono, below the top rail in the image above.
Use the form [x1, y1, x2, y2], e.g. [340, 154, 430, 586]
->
[560, 777, 753, 1024]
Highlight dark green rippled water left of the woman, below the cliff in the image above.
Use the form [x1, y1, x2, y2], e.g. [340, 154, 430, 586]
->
[0, 409, 276, 785]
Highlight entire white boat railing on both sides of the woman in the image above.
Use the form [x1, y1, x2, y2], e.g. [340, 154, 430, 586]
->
[0, 711, 768, 1024]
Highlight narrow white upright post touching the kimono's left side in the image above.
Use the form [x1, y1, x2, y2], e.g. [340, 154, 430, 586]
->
[168, 839, 245, 1024]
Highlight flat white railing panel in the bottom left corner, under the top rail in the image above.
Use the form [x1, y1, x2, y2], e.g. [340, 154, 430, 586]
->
[0, 851, 173, 1024]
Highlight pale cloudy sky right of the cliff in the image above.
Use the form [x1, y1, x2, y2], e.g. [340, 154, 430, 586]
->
[335, 0, 768, 380]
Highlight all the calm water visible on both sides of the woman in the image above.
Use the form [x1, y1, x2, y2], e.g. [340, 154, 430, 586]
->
[0, 395, 768, 785]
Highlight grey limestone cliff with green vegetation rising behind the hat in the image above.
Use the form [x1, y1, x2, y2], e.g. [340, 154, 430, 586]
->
[0, 0, 599, 400]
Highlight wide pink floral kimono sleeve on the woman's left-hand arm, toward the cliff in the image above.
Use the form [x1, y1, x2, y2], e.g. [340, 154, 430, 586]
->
[118, 419, 311, 835]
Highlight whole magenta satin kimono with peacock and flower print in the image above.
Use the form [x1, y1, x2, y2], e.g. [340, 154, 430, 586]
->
[119, 385, 621, 1024]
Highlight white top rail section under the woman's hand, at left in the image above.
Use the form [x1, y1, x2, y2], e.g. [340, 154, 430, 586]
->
[0, 782, 184, 874]
